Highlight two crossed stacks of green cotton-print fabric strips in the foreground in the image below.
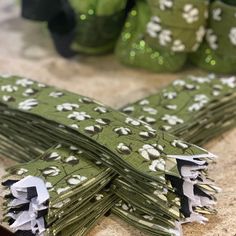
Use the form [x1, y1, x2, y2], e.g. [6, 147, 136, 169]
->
[0, 75, 236, 235]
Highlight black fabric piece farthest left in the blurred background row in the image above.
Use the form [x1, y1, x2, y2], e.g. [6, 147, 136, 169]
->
[21, 0, 62, 21]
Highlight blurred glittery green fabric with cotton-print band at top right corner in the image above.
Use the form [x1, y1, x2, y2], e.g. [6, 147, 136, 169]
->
[190, 1, 236, 73]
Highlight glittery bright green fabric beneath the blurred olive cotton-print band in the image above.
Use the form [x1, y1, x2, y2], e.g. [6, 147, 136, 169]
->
[116, 0, 186, 72]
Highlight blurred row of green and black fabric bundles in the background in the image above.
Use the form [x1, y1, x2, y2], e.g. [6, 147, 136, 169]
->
[19, 0, 236, 74]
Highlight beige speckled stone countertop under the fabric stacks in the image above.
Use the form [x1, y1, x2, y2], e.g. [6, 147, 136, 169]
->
[0, 0, 236, 236]
